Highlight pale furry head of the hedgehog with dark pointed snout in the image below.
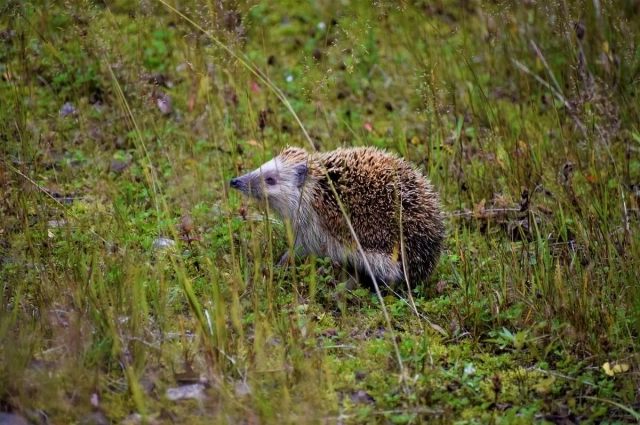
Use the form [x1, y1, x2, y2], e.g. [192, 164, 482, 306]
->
[229, 148, 309, 219]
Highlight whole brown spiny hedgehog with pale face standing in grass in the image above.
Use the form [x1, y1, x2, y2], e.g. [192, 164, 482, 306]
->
[229, 147, 445, 287]
